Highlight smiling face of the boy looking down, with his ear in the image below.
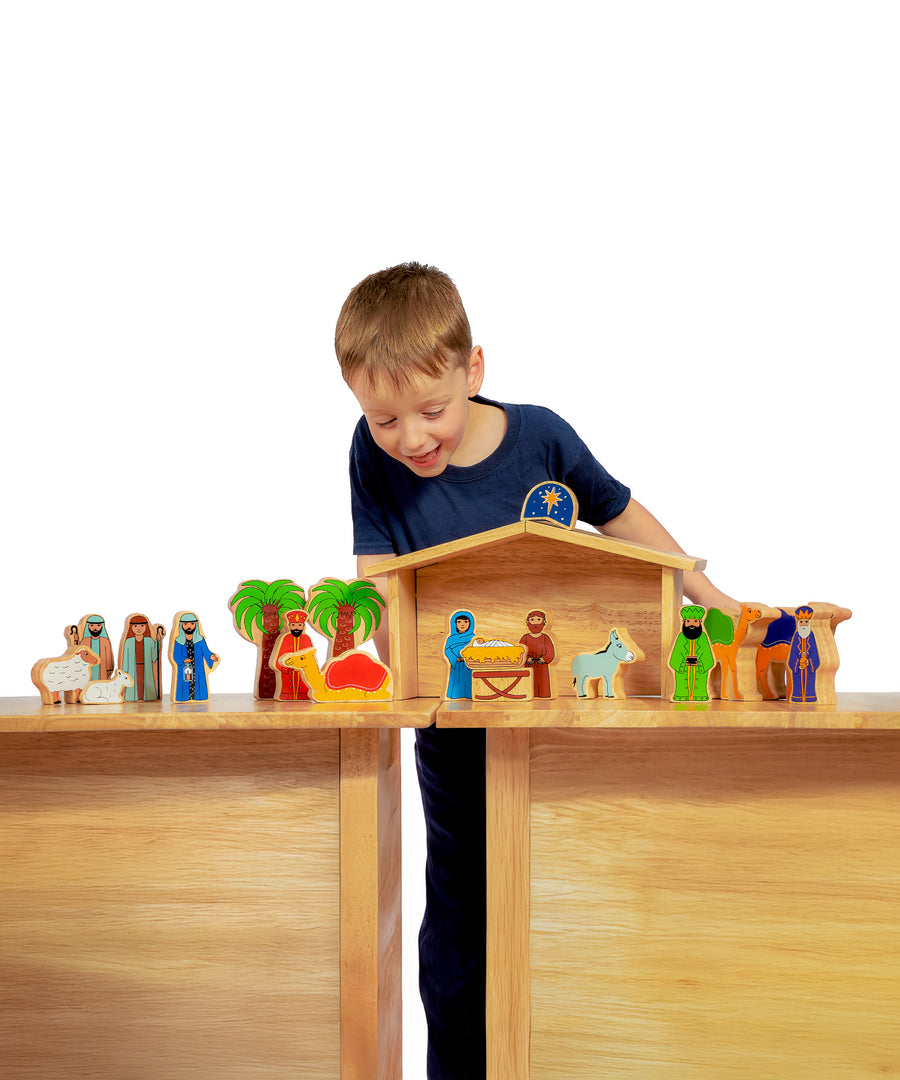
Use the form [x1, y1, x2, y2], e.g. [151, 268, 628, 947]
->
[350, 348, 484, 476]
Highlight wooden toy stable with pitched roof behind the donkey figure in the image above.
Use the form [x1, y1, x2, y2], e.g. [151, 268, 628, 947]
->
[368, 519, 706, 699]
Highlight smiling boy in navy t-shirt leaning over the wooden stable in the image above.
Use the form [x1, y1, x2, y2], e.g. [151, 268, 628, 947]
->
[335, 262, 739, 1080]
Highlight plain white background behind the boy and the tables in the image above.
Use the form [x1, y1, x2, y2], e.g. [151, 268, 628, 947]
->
[0, 0, 900, 1077]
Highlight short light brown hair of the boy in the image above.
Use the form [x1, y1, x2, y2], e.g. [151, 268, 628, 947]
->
[334, 262, 472, 389]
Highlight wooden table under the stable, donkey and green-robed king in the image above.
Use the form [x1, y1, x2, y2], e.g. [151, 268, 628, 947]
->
[438, 693, 900, 1080]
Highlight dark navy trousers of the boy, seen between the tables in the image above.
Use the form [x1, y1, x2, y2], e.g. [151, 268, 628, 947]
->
[416, 726, 486, 1080]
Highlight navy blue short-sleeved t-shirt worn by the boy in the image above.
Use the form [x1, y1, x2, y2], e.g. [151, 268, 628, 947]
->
[350, 397, 631, 555]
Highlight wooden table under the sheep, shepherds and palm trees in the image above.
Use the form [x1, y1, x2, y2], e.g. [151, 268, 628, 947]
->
[0, 694, 436, 1080]
